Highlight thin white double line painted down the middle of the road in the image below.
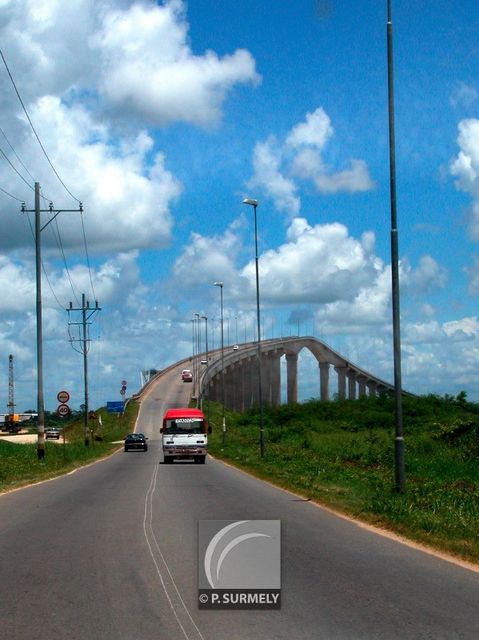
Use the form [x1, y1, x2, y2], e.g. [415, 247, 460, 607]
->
[143, 465, 205, 640]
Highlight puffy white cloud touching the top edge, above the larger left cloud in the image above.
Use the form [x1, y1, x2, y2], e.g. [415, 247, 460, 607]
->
[90, 0, 259, 126]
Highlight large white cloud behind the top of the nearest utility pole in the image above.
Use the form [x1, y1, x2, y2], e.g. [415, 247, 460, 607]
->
[0, 96, 181, 251]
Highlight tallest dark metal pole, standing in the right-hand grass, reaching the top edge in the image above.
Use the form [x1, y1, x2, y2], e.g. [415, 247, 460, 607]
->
[387, 0, 406, 493]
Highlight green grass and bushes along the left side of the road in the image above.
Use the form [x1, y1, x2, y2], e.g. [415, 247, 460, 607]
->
[0, 402, 139, 492]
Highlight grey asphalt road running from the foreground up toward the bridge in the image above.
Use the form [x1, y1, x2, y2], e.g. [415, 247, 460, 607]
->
[0, 370, 479, 640]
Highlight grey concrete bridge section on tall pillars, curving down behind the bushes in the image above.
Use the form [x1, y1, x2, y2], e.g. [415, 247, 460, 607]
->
[200, 337, 400, 412]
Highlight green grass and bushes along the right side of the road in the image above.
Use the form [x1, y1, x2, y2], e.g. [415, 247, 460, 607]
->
[205, 392, 479, 562]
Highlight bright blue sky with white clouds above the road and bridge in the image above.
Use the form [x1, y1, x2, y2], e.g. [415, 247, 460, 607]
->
[0, 0, 479, 413]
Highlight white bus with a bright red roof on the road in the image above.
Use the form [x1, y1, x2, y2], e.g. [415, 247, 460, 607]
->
[160, 408, 211, 464]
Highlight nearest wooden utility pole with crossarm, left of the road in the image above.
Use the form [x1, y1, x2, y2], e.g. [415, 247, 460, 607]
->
[22, 182, 83, 460]
